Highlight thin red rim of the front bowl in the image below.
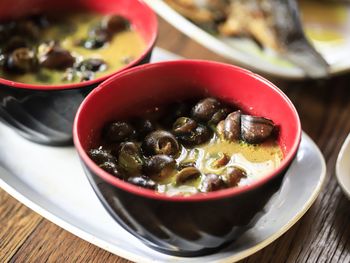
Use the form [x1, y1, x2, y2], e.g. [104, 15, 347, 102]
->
[73, 60, 302, 202]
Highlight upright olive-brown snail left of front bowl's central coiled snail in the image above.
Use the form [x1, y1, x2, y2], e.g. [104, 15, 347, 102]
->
[118, 142, 143, 175]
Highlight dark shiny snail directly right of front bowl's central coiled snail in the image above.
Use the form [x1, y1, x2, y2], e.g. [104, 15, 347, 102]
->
[176, 124, 212, 146]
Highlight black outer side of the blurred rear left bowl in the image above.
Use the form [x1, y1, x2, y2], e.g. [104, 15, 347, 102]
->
[0, 51, 152, 146]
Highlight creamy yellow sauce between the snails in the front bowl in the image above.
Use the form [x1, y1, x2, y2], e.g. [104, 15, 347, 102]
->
[155, 136, 283, 196]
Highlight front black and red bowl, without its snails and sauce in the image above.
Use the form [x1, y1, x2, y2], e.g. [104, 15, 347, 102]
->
[73, 60, 301, 256]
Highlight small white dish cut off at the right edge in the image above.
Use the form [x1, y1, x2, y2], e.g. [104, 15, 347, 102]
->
[335, 134, 350, 199]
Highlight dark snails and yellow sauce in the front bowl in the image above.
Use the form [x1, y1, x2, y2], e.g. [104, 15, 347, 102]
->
[89, 97, 283, 196]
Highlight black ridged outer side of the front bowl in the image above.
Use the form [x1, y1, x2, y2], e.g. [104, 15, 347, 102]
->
[83, 160, 286, 257]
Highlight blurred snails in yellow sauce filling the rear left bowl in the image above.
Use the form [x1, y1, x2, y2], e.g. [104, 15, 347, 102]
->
[0, 13, 145, 84]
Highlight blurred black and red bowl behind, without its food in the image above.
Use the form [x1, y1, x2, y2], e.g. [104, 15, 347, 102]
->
[0, 0, 158, 145]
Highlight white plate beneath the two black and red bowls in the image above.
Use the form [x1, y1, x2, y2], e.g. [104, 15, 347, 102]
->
[0, 49, 326, 263]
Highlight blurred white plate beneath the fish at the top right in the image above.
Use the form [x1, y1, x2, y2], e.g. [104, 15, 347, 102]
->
[145, 0, 350, 79]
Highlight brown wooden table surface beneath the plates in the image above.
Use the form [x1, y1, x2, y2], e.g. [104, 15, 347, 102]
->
[0, 20, 350, 263]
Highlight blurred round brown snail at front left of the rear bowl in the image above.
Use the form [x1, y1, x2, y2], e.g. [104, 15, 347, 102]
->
[6, 47, 37, 73]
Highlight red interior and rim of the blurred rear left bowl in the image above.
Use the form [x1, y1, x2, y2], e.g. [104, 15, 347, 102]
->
[0, 0, 158, 90]
